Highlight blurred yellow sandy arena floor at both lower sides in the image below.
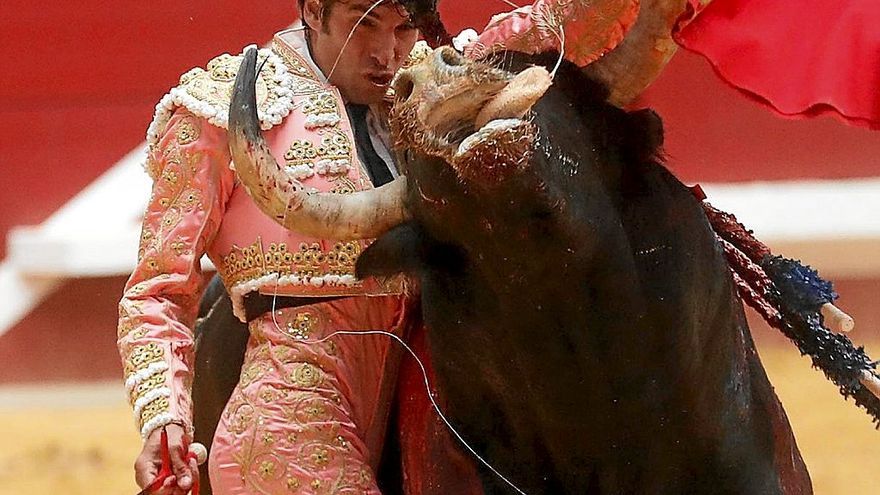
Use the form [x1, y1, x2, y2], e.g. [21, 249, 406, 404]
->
[0, 342, 880, 495]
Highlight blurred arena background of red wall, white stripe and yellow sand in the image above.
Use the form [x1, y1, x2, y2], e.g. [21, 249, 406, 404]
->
[0, 0, 880, 495]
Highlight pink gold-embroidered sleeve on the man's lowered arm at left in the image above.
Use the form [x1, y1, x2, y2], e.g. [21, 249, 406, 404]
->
[117, 109, 234, 438]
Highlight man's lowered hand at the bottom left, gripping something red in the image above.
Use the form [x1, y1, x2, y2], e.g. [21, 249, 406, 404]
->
[134, 424, 199, 495]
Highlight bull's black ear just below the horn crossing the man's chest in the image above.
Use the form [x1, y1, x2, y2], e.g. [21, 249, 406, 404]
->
[355, 222, 425, 279]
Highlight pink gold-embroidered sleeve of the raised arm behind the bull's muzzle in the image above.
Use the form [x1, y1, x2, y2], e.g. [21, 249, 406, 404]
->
[465, 0, 639, 66]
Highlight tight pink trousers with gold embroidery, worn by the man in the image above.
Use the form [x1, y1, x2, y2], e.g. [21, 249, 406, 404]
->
[208, 296, 405, 495]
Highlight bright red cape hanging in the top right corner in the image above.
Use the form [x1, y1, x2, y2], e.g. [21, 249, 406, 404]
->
[676, 0, 880, 129]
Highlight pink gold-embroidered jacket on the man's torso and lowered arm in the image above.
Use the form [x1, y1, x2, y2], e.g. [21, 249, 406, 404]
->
[118, 33, 401, 437]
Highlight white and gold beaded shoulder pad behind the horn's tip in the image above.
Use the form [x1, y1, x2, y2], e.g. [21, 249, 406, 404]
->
[147, 48, 302, 146]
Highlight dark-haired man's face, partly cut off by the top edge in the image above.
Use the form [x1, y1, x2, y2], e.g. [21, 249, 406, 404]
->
[303, 0, 418, 104]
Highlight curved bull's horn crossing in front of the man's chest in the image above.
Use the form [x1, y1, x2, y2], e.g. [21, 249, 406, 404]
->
[228, 48, 409, 240]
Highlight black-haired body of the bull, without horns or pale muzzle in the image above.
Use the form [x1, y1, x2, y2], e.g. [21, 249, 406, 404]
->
[194, 52, 812, 494]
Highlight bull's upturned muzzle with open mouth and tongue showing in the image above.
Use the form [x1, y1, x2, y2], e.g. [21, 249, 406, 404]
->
[391, 47, 550, 185]
